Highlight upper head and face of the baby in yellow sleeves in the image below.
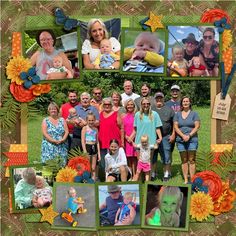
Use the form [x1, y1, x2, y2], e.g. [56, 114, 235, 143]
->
[135, 32, 160, 53]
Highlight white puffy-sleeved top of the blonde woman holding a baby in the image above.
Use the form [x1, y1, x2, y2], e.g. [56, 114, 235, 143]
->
[82, 37, 120, 63]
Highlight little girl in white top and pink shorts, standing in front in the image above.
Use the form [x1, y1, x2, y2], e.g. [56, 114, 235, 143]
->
[133, 135, 157, 181]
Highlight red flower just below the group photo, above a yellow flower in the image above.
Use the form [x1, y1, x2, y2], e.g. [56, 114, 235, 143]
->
[67, 156, 90, 175]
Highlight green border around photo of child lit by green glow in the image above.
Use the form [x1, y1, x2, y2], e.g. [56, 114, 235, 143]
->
[141, 181, 191, 232]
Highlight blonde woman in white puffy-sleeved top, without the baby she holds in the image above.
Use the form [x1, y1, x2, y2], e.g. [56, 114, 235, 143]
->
[82, 19, 120, 69]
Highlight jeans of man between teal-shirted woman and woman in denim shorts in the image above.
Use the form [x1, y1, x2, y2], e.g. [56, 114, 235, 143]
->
[152, 135, 175, 165]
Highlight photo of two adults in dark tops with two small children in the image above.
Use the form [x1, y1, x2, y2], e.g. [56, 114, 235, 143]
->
[167, 26, 220, 78]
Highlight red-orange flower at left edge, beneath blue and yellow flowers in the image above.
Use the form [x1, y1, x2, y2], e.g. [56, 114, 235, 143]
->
[10, 82, 35, 102]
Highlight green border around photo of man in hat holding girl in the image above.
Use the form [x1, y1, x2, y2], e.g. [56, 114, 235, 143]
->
[95, 181, 143, 230]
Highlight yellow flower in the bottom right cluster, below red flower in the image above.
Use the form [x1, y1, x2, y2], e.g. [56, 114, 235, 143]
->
[190, 192, 213, 221]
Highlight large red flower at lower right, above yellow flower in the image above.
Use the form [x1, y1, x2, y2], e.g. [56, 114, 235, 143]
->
[192, 170, 223, 202]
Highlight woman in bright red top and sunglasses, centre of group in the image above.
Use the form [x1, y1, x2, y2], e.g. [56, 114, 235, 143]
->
[98, 98, 123, 180]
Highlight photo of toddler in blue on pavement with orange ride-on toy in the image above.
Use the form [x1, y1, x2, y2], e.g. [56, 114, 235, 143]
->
[53, 183, 96, 229]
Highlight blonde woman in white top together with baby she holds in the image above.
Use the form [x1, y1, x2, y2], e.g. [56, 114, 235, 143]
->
[82, 19, 120, 69]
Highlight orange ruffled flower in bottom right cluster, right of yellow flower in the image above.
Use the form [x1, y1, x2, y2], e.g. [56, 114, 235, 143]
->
[211, 181, 236, 215]
